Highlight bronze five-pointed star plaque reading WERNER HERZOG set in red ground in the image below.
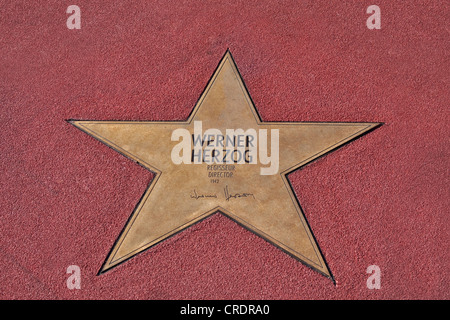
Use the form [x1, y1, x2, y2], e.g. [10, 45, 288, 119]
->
[70, 50, 378, 278]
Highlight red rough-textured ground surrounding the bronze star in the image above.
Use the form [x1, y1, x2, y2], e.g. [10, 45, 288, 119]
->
[0, 0, 450, 299]
